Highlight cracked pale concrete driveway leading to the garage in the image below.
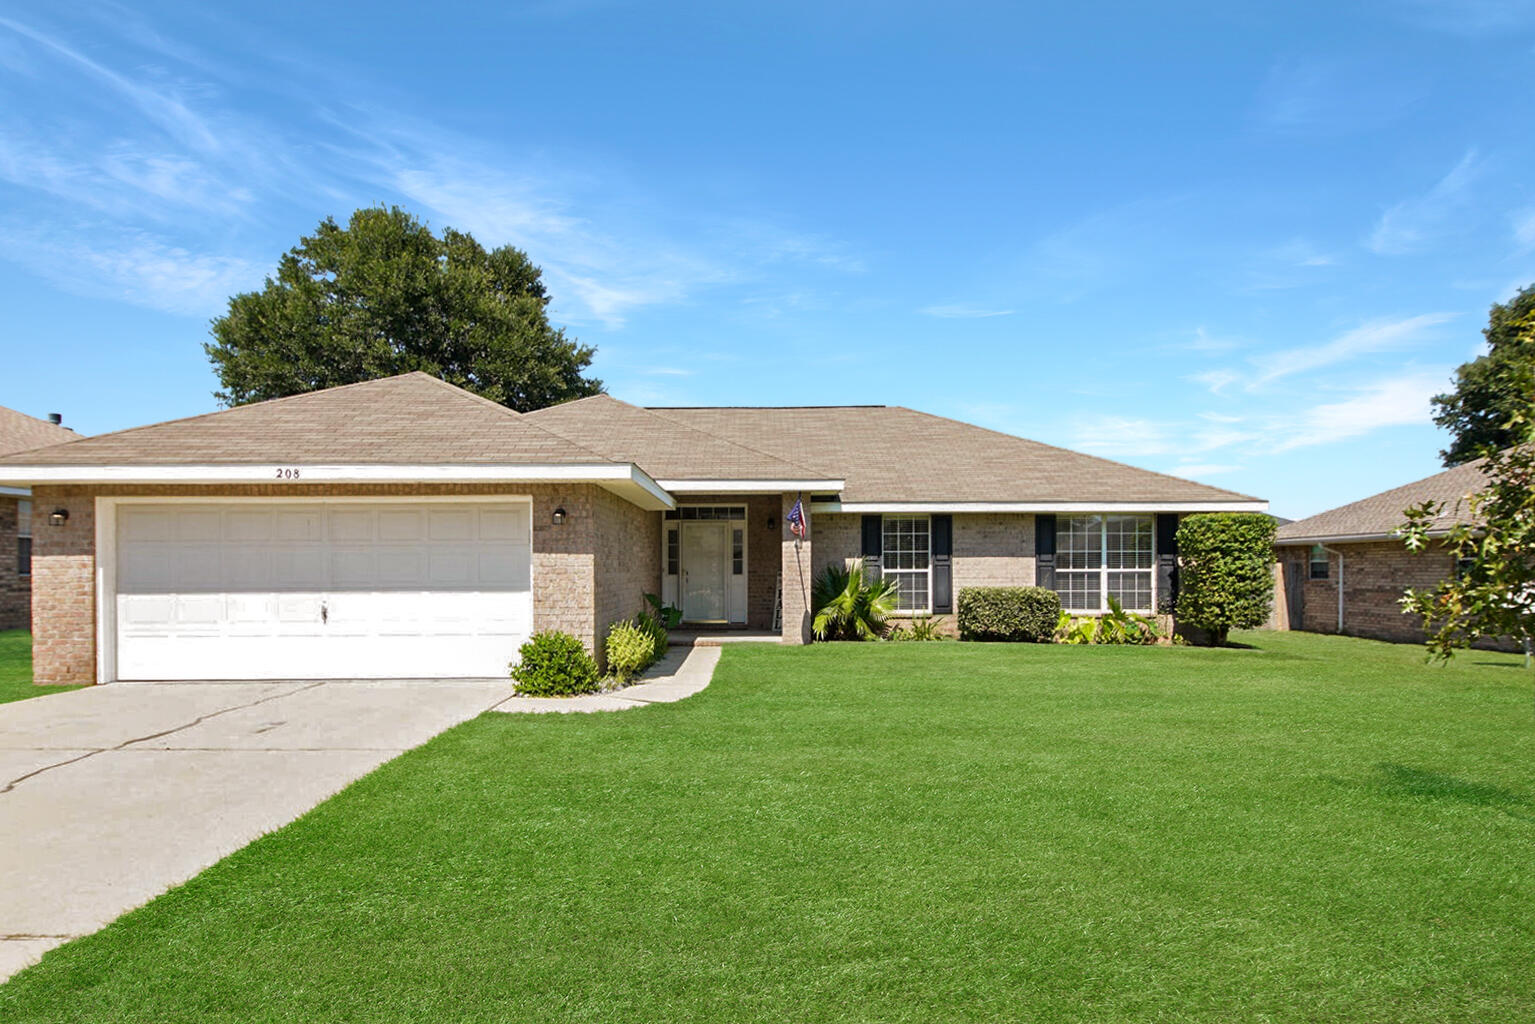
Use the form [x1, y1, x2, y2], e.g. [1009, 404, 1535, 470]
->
[0, 680, 511, 979]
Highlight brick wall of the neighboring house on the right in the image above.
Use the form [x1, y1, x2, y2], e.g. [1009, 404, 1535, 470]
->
[1274, 540, 1455, 643]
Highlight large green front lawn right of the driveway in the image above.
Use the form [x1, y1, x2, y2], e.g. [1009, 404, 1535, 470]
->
[0, 634, 1535, 1024]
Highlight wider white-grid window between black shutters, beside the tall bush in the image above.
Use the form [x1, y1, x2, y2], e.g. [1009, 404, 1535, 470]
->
[1056, 516, 1156, 613]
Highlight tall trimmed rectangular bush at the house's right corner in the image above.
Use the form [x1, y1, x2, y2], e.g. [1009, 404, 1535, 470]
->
[1177, 513, 1274, 643]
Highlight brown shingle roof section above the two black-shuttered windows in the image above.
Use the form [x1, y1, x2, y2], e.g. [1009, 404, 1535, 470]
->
[651, 405, 1260, 508]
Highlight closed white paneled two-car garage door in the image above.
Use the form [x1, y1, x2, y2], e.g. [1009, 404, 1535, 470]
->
[115, 500, 533, 680]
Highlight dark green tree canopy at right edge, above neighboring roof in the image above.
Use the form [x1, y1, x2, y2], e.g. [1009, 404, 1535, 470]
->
[1434, 284, 1535, 465]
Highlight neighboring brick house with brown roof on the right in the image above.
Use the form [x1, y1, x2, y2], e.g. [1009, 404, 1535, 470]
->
[1274, 461, 1486, 643]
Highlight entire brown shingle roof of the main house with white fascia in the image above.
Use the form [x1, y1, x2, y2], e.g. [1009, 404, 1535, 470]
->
[0, 373, 1265, 511]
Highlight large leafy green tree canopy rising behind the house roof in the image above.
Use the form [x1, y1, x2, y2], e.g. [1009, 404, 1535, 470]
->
[204, 206, 602, 411]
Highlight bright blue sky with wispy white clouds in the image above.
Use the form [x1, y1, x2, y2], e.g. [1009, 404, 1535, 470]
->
[0, 0, 1535, 516]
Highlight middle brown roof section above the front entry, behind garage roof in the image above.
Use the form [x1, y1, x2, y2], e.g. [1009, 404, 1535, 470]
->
[523, 395, 827, 487]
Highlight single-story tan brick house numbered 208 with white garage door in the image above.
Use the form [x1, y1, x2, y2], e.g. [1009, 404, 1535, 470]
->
[0, 373, 1266, 683]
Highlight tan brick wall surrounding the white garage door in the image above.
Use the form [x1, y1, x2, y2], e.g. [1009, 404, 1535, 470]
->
[29, 484, 660, 685]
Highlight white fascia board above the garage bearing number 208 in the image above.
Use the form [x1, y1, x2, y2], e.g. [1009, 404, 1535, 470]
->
[0, 462, 675, 508]
